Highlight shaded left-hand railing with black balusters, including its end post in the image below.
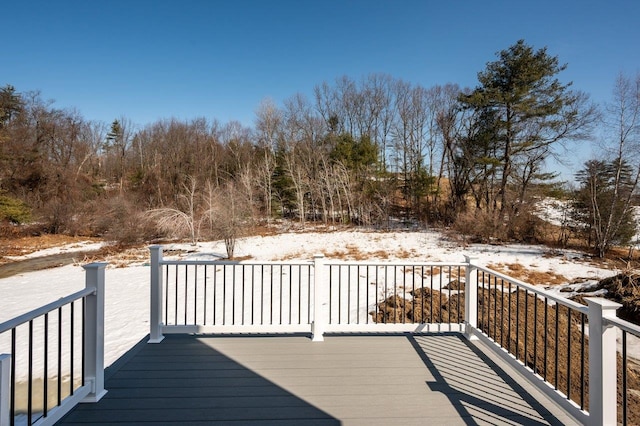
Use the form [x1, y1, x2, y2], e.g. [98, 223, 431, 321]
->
[0, 263, 106, 426]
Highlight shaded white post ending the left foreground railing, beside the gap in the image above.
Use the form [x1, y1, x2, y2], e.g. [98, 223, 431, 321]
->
[82, 263, 107, 402]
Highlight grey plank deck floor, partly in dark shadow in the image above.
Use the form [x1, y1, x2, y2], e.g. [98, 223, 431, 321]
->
[58, 334, 576, 425]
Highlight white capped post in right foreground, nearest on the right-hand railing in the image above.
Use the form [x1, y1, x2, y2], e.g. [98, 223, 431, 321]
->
[585, 297, 622, 425]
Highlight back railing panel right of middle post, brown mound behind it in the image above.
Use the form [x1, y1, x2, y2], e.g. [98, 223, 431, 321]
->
[319, 261, 466, 332]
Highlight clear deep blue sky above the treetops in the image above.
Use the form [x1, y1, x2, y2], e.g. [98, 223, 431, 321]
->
[5, 0, 640, 131]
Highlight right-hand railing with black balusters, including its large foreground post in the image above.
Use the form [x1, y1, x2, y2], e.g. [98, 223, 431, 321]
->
[470, 261, 640, 425]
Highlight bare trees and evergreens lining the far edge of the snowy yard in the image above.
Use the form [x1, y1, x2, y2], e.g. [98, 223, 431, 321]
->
[0, 41, 640, 252]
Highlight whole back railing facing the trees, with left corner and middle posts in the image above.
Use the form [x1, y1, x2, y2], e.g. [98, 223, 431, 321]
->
[150, 246, 466, 343]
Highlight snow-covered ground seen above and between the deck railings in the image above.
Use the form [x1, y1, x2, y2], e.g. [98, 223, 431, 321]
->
[0, 230, 617, 374]
